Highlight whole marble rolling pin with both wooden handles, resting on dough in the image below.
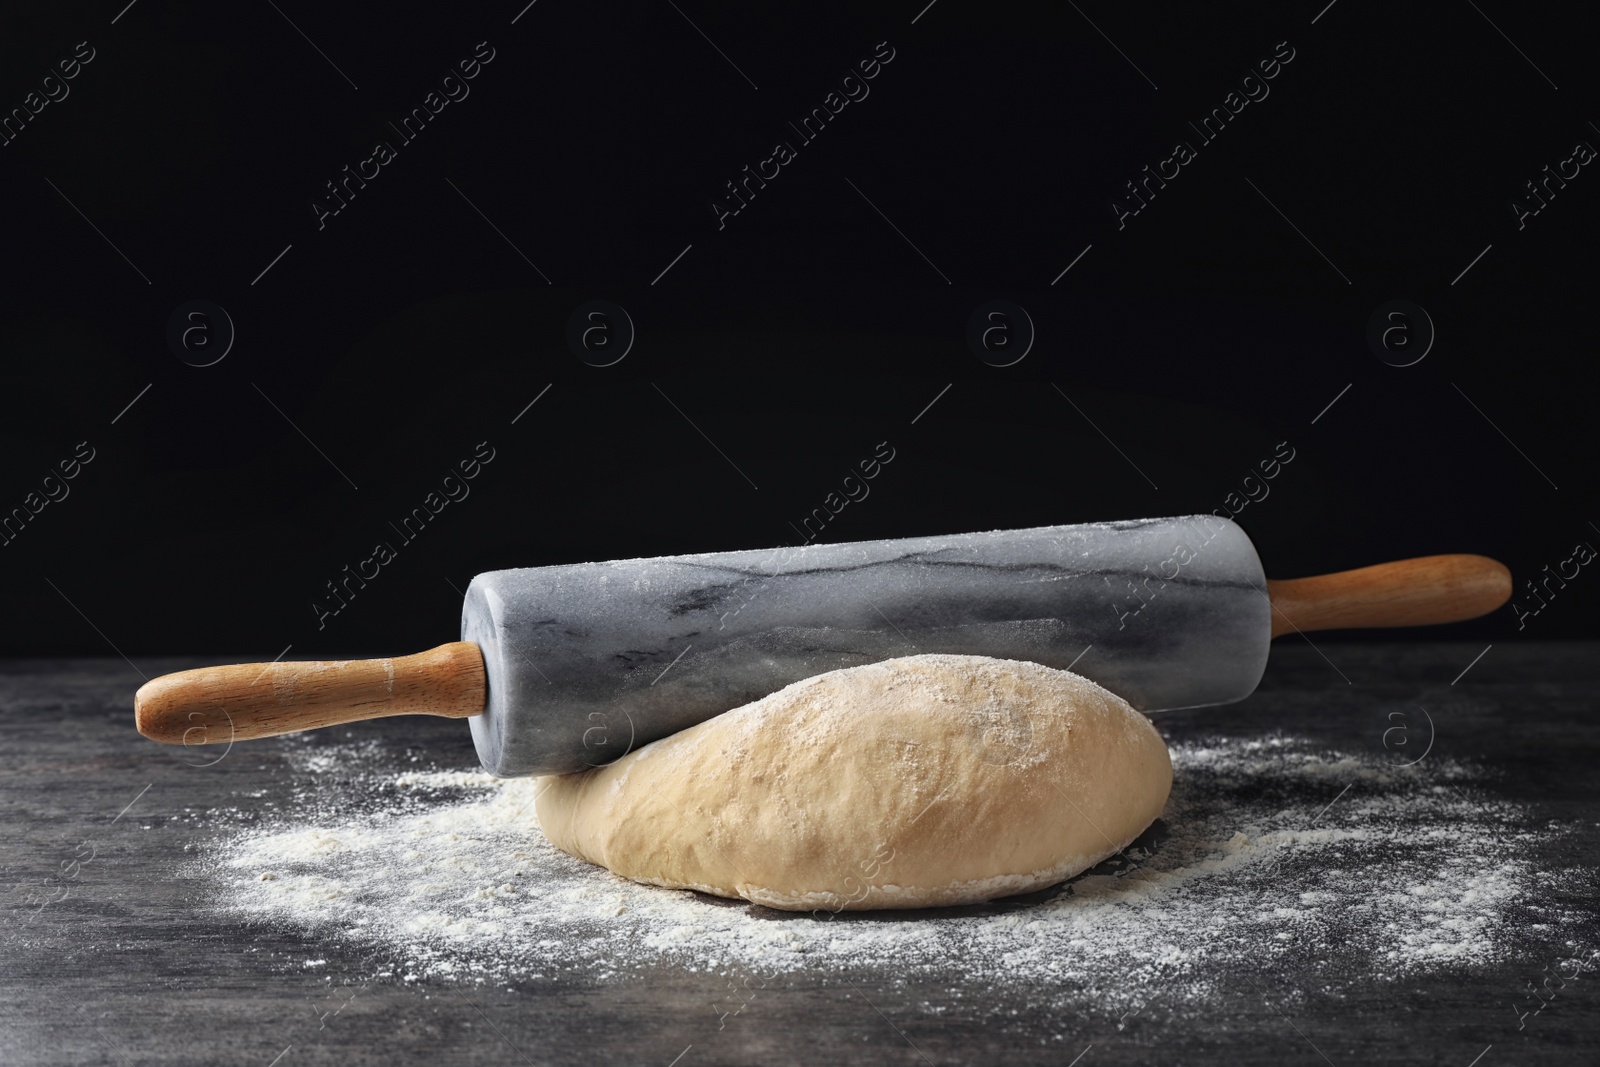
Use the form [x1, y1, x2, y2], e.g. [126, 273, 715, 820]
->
[134, 515, 1510, 777]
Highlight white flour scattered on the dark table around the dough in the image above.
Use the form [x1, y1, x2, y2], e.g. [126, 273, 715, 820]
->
[189, 736, 1576, 1006]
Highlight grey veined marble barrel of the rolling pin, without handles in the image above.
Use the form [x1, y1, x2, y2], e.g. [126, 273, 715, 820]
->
[461, 515, 1272, 776]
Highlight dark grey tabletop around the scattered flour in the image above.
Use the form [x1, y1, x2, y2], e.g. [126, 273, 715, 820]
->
[0, 638, 1600, 1067]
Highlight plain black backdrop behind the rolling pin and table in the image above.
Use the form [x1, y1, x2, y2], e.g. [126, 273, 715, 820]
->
[0, 0, 1600, 659]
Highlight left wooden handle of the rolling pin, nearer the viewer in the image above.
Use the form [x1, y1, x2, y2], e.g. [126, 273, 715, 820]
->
[133, 641, 486, 745]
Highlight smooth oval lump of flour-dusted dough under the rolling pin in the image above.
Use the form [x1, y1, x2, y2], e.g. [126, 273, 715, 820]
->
[538, 654, 1173, 912]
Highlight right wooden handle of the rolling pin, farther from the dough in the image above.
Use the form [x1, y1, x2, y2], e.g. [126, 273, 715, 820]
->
[1267, 555, 1510, 637]
